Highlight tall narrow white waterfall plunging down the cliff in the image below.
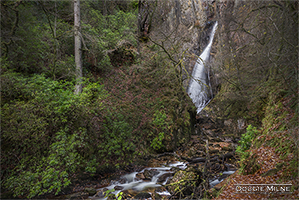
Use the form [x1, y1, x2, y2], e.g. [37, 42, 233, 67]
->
[187, 22, 218, 113]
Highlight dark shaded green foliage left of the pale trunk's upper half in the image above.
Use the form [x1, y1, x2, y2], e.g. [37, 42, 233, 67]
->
[1, 2, 74, 80]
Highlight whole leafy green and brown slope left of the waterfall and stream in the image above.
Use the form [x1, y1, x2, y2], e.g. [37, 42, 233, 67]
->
[0, 0, 197, 199]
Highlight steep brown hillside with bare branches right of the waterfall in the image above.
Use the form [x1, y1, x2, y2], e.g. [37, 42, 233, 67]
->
[209, 1, 299, 199]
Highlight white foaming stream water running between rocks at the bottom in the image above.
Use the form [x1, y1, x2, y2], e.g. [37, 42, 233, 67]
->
[88, 152, 235, 200]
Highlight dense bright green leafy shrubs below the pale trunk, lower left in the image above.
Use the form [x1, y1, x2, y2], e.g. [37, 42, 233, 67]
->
[1, 72, 105, 198]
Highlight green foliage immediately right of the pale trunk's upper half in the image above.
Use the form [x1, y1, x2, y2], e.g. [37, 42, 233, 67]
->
[82, 1, 137, 71]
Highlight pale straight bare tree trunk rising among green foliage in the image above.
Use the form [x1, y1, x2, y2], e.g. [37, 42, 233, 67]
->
[74, 0, 82, 94]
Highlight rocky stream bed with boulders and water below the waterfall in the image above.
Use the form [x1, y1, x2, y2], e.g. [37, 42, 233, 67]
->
[55, 111, 241, 199]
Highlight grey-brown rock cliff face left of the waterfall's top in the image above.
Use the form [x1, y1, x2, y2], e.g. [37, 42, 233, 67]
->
[140, 0, 216, 87]
